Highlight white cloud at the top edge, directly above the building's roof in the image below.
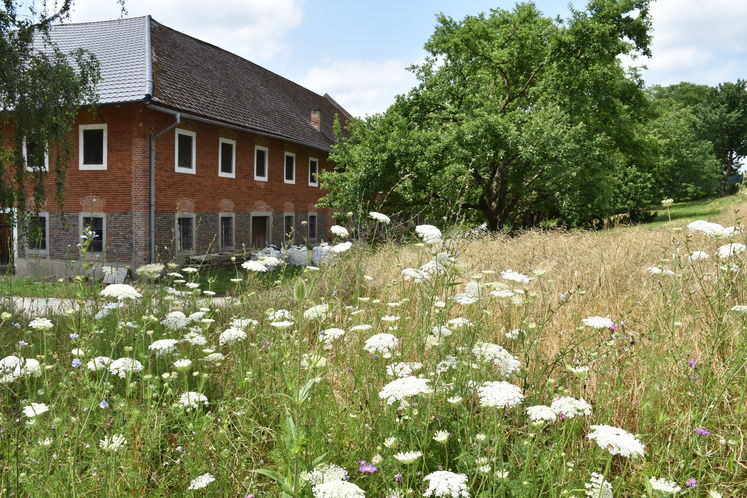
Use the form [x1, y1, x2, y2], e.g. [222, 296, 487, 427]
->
[70, 0, 303, 61]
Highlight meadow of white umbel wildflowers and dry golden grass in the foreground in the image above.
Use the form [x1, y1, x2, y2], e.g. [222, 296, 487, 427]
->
[0, 201, 747, 498]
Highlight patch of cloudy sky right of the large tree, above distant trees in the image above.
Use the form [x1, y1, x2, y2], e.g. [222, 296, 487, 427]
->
[637, 0, 747, 85]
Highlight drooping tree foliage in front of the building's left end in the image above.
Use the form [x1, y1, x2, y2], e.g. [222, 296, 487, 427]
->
[0, 0, 106, 210]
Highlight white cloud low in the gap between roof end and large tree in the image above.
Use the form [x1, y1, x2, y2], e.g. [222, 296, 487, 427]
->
[299, 59, 417, 116]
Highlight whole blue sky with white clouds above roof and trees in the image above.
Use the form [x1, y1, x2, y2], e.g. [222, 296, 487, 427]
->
[64, 0, 747, 116]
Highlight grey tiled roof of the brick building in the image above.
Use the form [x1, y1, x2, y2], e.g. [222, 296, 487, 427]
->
[43, 16, 350, 150]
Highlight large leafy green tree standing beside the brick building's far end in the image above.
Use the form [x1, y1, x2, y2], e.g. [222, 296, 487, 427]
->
[323, 0, 650, 229]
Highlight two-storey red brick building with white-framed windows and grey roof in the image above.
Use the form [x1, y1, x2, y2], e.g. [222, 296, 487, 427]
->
[0, 16, 350, 274]
